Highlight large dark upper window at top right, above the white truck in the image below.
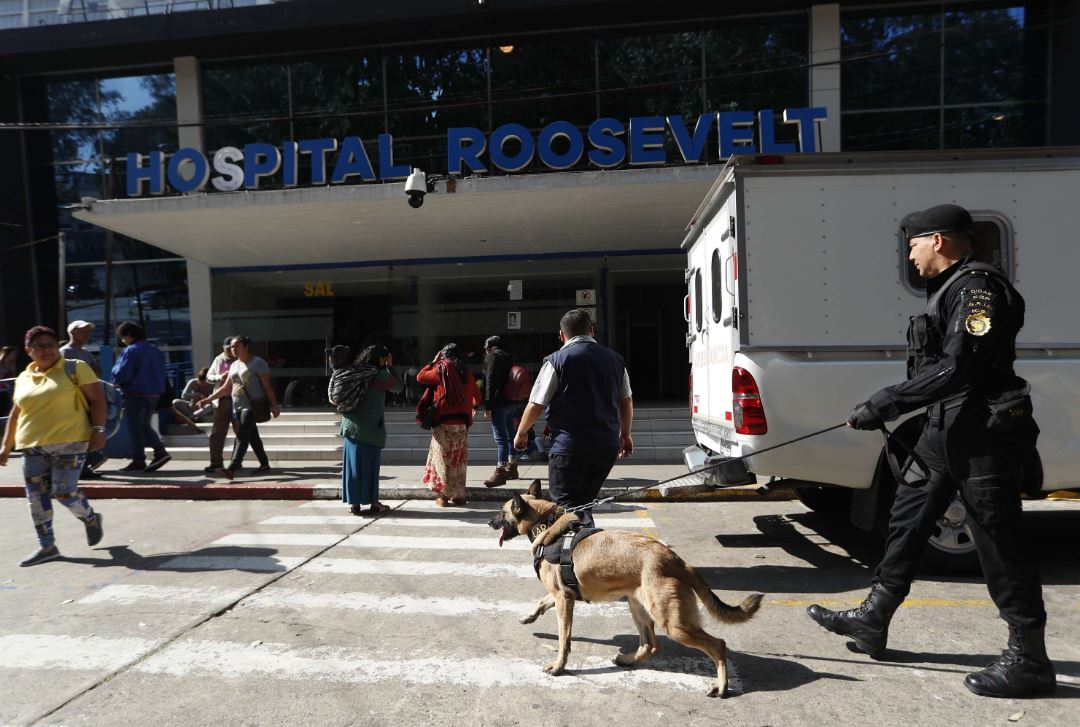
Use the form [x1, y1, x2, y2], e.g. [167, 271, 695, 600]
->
[840, 2, 1049, 151]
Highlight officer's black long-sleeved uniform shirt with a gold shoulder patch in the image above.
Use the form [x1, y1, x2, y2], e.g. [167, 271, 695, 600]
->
[869, 257, 1024, 421]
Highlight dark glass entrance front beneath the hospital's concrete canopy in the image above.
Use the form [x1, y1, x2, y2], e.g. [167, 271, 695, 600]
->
[213, 253, 687, 406]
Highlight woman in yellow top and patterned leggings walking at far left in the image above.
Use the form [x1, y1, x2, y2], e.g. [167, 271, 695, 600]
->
[0, 325, 106, 566]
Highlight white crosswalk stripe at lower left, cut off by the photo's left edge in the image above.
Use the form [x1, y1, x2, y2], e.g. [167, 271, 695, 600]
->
[0, 634, 158, 671]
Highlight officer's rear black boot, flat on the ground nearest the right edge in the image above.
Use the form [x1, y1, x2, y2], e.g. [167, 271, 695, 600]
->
[963, 627, 1057, 697]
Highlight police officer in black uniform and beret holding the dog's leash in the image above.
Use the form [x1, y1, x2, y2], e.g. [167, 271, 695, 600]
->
[807, 204, 1055, 697]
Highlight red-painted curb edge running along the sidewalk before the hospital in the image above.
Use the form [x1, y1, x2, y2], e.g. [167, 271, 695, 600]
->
[0, 482, 795, 502]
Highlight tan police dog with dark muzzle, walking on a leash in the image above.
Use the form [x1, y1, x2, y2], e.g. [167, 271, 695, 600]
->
[488, 480, 762, 697]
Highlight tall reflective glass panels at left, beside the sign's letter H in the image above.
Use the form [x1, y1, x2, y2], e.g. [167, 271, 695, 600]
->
[22, 72, 191, 367]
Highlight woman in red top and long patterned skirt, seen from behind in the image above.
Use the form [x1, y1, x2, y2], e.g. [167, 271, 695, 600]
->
[416, 344, 483, 508]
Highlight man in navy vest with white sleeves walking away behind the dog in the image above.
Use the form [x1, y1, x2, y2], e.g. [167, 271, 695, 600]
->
[514, 310, 634, 526]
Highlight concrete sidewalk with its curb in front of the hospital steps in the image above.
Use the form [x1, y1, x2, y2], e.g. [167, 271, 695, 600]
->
[0, 459, 795, 501]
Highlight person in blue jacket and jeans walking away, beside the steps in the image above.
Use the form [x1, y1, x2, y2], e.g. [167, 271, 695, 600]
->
[112, 321, 172, 472]
